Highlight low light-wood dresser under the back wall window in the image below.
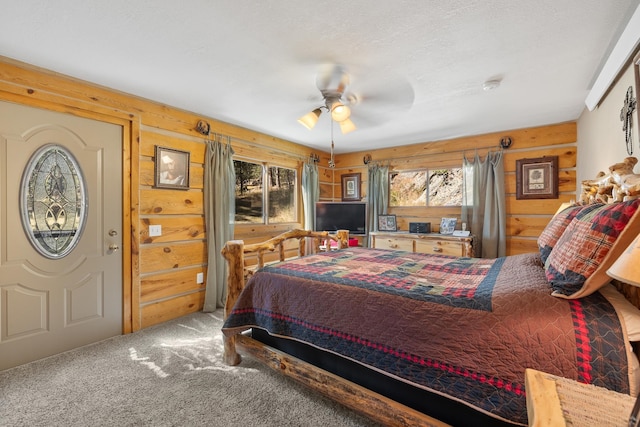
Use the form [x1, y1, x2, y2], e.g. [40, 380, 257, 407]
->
[370, 231, 474, 257]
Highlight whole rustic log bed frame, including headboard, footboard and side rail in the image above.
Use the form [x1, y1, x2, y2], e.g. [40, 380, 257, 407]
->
[222, 158, 640, 426]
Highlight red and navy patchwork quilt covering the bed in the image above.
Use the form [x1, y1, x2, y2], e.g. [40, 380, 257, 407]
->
[223, 248, 629, 425]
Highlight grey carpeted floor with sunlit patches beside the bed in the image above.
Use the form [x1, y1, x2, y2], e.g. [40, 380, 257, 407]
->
[0, 311, 375, 427]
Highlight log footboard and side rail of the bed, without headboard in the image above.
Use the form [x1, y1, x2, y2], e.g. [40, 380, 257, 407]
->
[222, 230, 447, 427]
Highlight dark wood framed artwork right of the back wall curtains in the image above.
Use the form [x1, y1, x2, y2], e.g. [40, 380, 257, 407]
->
[516, 156, 558, 200]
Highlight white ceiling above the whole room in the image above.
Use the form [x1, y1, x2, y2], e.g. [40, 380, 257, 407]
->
[0, 0, 640, 153]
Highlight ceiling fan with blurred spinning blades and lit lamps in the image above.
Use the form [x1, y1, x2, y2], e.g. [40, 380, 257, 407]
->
[298, 64, 414, 134]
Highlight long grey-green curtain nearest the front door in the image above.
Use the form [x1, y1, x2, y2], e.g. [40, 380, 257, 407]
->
[204, 135, 236, 311]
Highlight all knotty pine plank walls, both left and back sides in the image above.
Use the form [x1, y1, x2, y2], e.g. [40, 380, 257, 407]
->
[0, 57, 576, 332]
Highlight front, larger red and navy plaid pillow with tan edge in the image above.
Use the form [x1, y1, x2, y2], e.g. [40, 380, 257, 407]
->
[545, 199, 640, 298]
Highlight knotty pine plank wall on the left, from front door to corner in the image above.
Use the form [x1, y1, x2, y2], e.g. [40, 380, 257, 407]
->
[0, 57, 324, 333]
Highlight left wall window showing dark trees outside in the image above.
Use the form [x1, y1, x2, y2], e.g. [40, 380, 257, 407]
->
[233, 160, 297, 224]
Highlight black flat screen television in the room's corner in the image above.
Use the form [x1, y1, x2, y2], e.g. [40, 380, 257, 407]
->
[315, 202, 367, 236]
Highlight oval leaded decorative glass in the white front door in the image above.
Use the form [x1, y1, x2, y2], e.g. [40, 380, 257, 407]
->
[20, 144, 87, 259]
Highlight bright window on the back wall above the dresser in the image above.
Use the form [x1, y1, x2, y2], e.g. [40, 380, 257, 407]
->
[389, 168, 462, 207]
